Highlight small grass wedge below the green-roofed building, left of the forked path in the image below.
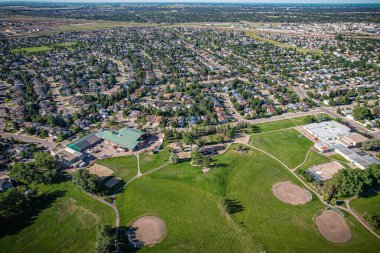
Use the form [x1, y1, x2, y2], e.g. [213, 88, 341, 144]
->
[97, 156, 137, 182]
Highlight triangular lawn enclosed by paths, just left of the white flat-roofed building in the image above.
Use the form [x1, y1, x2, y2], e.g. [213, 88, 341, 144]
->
[250, 129, 313, 168]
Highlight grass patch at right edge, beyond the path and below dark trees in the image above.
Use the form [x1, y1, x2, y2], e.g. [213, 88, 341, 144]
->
[350, 193, 380, 234]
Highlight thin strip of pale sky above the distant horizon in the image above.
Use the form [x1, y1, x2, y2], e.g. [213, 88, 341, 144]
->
[0, 0, 380, 4]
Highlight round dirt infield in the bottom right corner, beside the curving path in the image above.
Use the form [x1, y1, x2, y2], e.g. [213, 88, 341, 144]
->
[315, 210, 351, 243]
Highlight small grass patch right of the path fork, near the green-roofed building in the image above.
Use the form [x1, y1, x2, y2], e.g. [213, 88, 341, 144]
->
[140, 148, 171, 173]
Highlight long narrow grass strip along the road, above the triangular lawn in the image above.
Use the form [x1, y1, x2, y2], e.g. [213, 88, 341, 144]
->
[252, 116, 316, 133]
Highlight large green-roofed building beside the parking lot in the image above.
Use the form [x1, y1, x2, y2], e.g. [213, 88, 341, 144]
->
[96, 128, 145, 150]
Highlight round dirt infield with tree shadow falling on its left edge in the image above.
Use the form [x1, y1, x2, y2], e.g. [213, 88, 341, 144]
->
[128, 216, 166, 248]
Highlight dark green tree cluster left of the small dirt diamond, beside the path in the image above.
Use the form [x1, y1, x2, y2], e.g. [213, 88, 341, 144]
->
[73, 169, 102, 193]
